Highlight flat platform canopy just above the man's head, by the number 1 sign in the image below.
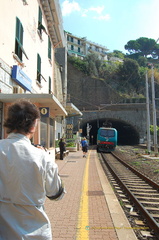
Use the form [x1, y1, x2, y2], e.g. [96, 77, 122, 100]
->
[0, 93, 67, 117]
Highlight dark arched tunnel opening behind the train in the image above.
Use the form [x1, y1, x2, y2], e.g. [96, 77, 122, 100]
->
[81, 119, 139, 145]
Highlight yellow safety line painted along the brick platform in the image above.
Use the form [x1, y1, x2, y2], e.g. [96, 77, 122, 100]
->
[76, 151, 90, 240]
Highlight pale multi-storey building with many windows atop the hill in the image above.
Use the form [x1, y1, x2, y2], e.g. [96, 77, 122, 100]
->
[65, 32, 108, 60]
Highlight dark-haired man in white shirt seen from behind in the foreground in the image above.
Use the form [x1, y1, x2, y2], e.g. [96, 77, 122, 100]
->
[0, 99, 65, 240]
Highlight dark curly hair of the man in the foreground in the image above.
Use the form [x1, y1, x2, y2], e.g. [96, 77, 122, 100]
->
[3, 99, 40, 133]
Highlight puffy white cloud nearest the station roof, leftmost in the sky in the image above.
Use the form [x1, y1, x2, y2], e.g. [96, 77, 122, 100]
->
[62, 0, 81, 16]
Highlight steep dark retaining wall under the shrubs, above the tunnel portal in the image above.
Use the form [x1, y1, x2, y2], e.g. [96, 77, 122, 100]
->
[67, 62, 122, 111]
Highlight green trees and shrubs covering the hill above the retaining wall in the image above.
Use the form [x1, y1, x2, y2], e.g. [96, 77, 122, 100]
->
[68, 37, 159, 99]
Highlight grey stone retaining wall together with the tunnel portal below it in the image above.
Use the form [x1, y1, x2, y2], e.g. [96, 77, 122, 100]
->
[68, 63, 147, 143]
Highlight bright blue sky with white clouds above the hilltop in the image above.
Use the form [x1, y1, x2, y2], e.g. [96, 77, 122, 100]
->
[59, 0, 159, 53]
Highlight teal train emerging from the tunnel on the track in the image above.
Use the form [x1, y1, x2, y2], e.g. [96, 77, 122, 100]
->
[97, 127, 118, 152]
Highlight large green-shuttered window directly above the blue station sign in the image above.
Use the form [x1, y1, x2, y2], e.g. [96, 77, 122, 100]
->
[15, 18, 28, 61]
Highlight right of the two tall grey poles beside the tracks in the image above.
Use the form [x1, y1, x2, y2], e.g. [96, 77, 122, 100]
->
[151, 65, 158, 153]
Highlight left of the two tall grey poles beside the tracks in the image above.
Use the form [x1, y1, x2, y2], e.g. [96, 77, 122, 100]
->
[146, 71, 151, 153]
